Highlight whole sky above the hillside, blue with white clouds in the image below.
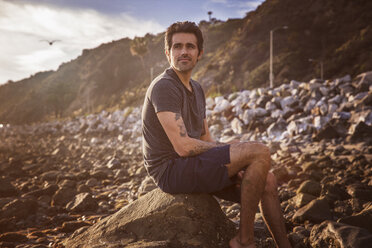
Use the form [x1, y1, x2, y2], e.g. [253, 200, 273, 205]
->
[0, 0, 264, 85]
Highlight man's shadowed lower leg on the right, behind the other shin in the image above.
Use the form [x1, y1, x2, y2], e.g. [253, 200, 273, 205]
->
[260, 172, 291, 248]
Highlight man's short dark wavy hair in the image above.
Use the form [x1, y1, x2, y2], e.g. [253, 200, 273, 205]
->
[164, 21, 204, 53]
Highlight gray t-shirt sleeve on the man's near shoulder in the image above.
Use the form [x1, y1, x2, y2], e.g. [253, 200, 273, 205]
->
[150, 80, 182, 113]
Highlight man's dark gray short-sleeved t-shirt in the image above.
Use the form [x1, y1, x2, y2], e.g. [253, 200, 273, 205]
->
[142, 68, 205, 183]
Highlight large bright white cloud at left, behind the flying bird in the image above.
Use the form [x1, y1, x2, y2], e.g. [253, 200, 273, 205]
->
[0, 1, 165, 84]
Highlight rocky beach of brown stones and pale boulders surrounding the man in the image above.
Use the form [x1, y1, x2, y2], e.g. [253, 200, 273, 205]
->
[0, 72, 372, 248]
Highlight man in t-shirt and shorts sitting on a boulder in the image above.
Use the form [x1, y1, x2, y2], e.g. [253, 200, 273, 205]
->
[142, 22, 290, 247]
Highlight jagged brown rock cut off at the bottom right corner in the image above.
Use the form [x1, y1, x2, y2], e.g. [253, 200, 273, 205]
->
[310, 221, 372, 248]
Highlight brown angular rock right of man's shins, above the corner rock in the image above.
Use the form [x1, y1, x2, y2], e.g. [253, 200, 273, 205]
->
[293, 198, 332, 223]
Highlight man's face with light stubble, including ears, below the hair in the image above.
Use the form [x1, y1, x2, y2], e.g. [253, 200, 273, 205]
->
[165, 33, 203, 72]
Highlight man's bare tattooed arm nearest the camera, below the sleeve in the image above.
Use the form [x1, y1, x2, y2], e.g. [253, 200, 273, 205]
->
[157, 111, 223, 157]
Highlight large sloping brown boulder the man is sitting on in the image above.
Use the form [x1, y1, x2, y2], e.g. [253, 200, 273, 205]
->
[64, 189, 235, 248]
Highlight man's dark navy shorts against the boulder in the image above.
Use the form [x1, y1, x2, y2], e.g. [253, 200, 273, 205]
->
[159, 145, 240, 202]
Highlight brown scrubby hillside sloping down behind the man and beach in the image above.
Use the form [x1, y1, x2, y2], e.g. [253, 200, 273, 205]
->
[0, 0, 372, 124]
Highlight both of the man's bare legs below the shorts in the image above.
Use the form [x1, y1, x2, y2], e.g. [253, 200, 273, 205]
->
[227, 142, 290, 247]
